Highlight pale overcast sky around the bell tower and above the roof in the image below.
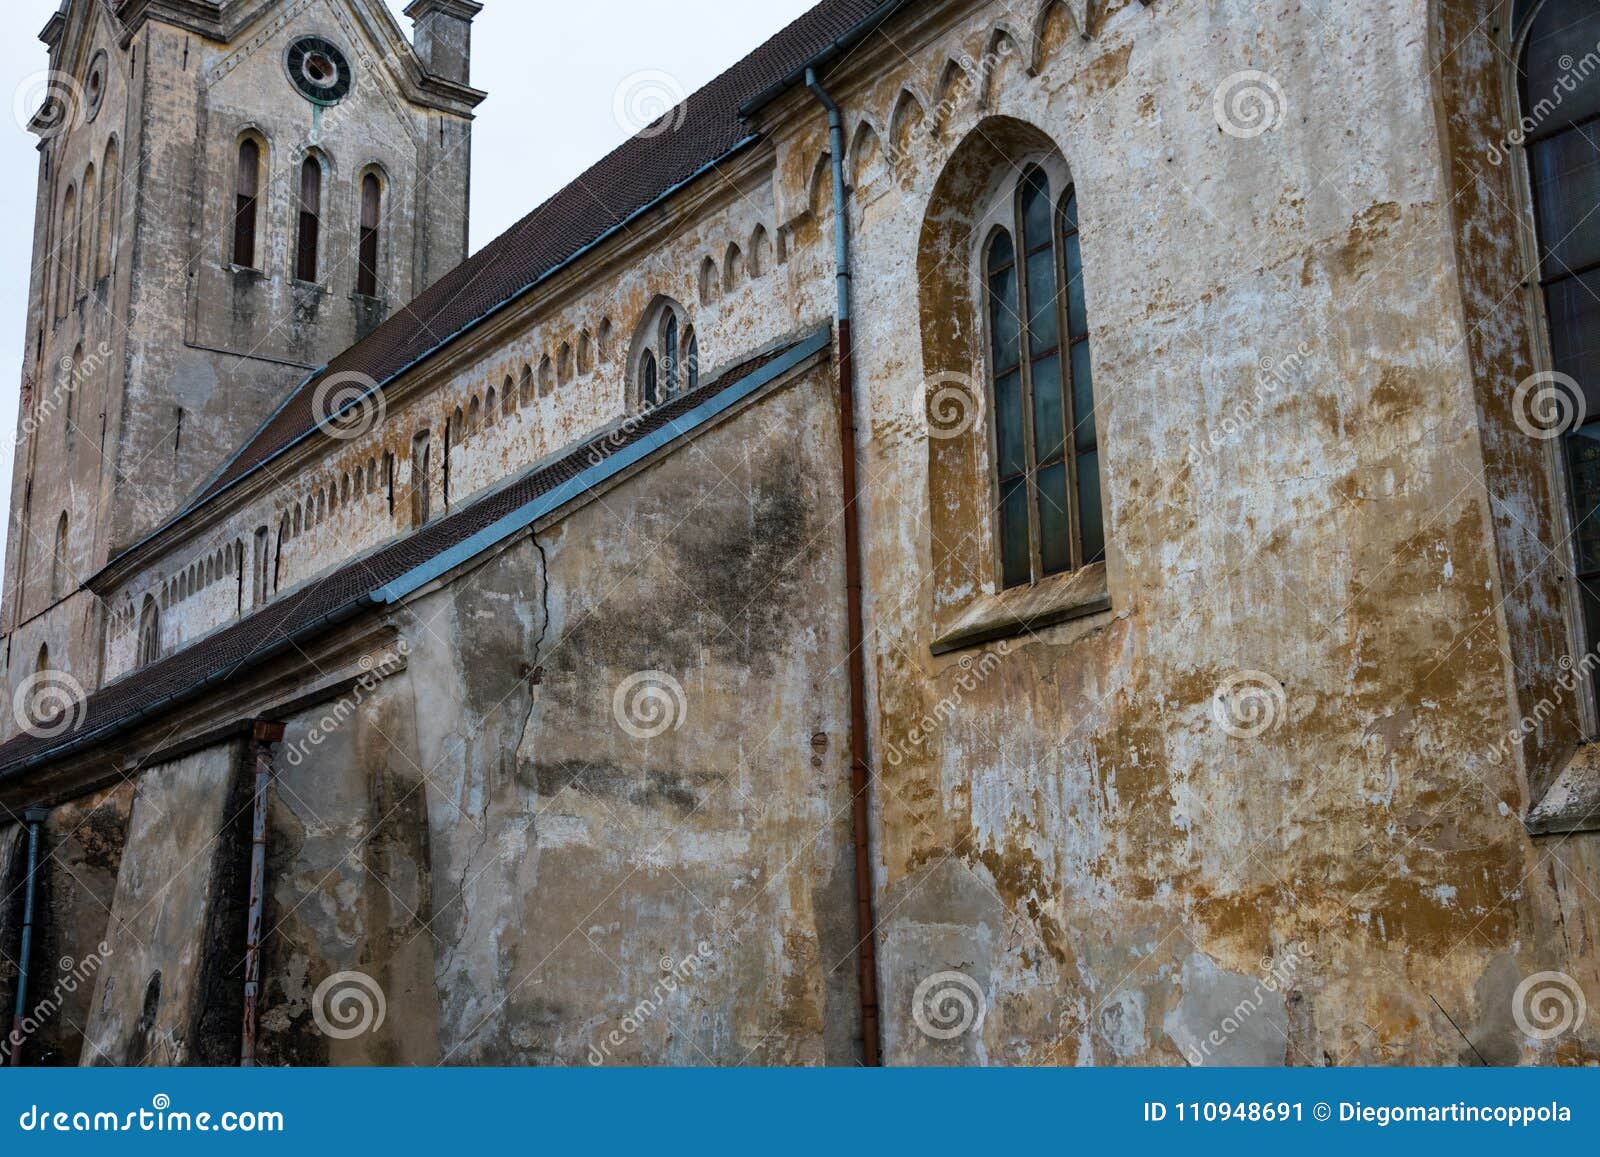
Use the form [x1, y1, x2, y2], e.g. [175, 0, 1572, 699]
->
[0, 0, 814, 576]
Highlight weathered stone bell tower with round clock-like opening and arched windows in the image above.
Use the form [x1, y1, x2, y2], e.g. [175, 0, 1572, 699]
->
[0, 0, 483, 714]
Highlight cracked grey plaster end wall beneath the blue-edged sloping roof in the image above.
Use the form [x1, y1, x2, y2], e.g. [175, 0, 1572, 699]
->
[411, 366, 859, 1064]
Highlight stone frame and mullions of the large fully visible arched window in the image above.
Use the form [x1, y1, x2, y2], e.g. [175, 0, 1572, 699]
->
[971, 154, 1106, 592]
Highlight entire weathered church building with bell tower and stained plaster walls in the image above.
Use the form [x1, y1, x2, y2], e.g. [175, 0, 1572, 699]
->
[0, 0, 1600, 1066]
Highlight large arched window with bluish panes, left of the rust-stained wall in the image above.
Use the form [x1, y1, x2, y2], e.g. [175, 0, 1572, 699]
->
[984, 168, 1106, 587]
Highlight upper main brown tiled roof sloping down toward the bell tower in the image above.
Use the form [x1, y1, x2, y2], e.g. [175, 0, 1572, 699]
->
[194, 0, 891, 504]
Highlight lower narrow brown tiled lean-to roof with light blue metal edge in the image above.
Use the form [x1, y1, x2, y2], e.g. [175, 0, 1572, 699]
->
[0, 330, 829, 781]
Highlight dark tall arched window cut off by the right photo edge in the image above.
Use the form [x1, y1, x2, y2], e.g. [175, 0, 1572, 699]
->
[1518, 0, 1600, 697]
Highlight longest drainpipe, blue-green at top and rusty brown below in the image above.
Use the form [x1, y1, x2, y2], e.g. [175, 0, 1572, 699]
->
[805, 69, 882, 1067]
